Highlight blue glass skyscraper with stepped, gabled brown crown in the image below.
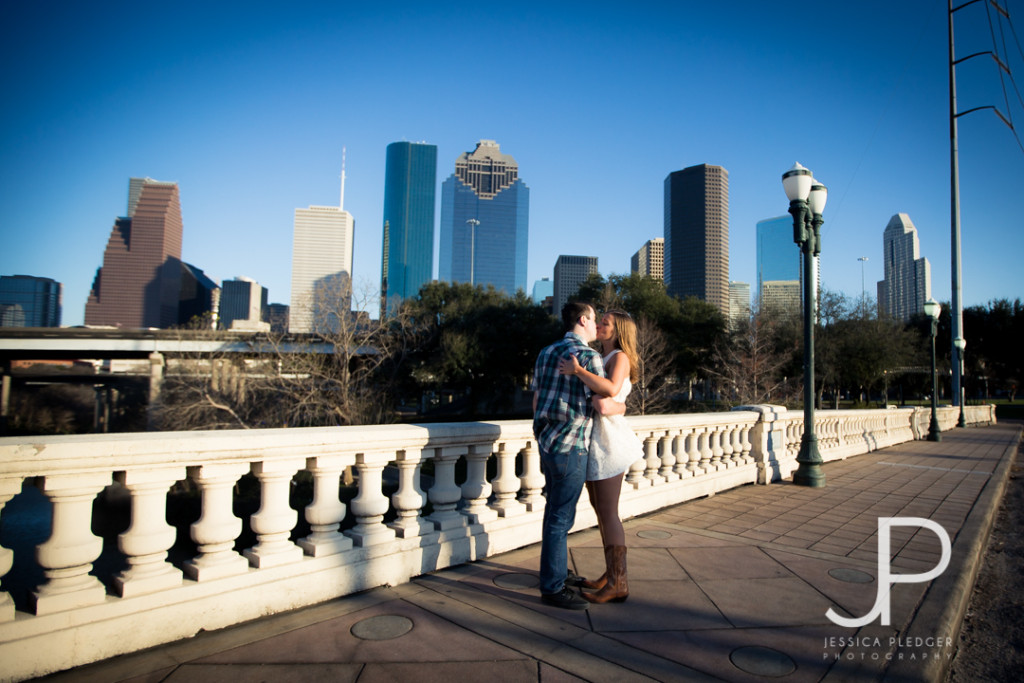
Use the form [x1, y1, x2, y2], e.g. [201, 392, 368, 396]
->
[439, 140, 529, 294]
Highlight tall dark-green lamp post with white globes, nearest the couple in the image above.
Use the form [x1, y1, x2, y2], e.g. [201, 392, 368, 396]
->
[782, 163, 828, 487]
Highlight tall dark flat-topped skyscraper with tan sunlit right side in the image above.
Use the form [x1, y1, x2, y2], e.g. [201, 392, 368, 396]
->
[665, 164, 729, 317]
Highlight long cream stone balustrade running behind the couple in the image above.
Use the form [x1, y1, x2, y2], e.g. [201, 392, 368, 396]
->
[0, 405, 994, 680]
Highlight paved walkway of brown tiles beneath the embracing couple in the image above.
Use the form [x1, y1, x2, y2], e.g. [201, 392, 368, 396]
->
[47, 424, 1021, 683]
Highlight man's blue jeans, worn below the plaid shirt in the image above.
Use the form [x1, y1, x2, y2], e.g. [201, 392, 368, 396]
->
[540, 447, 587, 595]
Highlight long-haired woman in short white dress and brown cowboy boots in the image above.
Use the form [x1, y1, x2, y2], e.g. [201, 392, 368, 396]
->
[558, 310, 643, 603]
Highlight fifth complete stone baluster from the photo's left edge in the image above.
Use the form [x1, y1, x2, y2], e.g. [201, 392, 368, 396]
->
[298, 456, 352, 557]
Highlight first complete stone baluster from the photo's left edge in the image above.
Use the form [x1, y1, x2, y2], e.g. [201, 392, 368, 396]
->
[32, 472, 113, 614]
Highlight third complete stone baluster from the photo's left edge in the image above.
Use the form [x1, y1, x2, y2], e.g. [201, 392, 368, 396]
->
[182, 463, 249, 581]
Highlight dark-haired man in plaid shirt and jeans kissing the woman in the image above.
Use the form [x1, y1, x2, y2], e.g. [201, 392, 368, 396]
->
[532, 301, 626, 609]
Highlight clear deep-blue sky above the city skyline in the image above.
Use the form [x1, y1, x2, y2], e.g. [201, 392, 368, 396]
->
[0, 0, 1024, 325]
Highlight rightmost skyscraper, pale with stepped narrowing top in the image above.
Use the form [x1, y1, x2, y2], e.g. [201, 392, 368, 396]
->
[878, 213, 932, 321]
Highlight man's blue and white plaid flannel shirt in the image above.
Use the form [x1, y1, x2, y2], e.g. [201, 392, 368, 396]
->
[532, 332, 604, 454]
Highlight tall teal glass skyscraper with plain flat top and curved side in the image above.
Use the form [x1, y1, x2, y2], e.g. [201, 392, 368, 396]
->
[381, 142, 437, 309]
